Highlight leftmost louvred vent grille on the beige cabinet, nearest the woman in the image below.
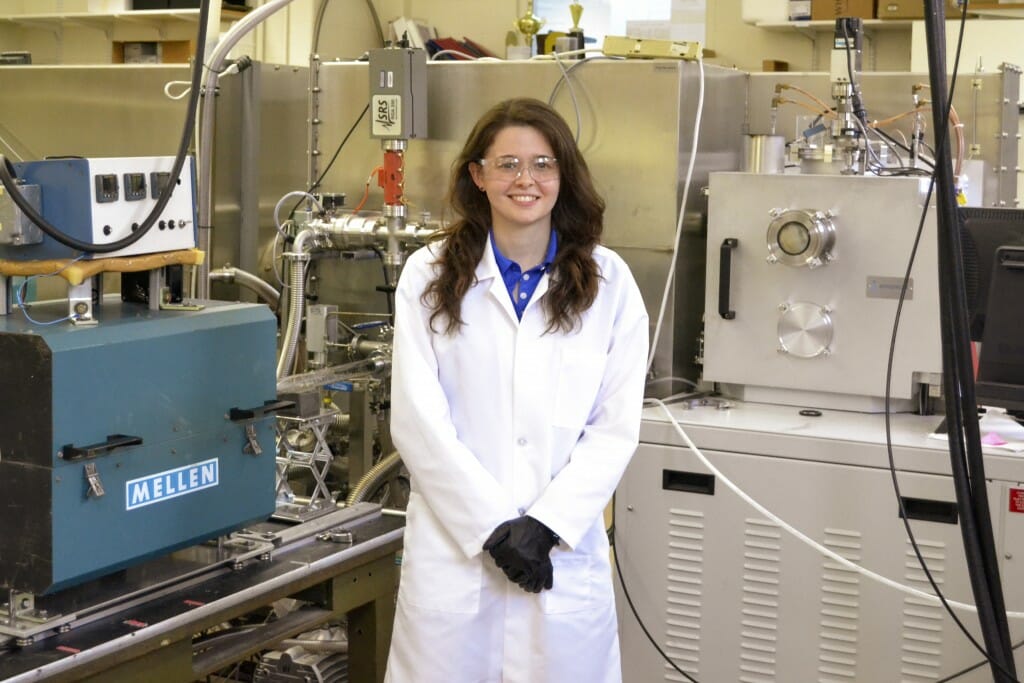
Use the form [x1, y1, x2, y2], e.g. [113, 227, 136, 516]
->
[665, 508, 705, 681]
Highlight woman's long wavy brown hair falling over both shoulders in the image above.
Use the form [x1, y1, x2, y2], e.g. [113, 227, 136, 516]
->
[422, 98, 604, 334]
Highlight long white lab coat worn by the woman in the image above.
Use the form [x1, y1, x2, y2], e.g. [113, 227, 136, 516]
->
[385, 236, 648, 683]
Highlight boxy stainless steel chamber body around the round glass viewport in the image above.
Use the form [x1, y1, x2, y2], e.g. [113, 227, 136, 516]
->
[705, 173, 942, 410]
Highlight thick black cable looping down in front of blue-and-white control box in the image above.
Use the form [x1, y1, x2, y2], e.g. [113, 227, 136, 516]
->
[0, 0, 210, 254]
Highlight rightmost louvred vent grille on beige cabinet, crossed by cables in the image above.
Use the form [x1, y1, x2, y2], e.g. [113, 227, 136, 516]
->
[900, 539, 946, 683]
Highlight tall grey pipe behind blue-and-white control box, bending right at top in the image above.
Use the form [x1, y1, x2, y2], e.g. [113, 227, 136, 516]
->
[194, 0, 292, 299]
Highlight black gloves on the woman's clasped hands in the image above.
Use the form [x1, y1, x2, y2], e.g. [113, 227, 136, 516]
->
[483, 516, 558, 593]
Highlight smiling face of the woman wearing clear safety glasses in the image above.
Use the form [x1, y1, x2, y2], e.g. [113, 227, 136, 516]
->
[470, 126, 560, 243]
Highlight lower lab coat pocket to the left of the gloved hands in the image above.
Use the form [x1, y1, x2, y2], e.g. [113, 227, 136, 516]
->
[399, 493, 483, 614]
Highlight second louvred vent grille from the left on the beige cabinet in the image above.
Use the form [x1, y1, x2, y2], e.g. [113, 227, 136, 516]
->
[738, 519, 782, 683]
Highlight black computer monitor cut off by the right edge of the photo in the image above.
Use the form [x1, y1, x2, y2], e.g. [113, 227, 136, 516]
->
[959, 207, 1024, 412]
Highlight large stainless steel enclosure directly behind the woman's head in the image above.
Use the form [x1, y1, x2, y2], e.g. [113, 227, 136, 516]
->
[319, 60, 746, 379]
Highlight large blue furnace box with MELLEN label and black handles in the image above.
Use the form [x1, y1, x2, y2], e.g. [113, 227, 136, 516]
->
[0, 299, 276, 595]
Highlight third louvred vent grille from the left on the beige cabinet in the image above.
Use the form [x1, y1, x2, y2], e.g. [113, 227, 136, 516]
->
[818, 528, 863, 683]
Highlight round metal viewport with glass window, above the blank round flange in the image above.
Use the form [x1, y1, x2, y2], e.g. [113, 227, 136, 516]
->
[767, 209, 836, 268]
